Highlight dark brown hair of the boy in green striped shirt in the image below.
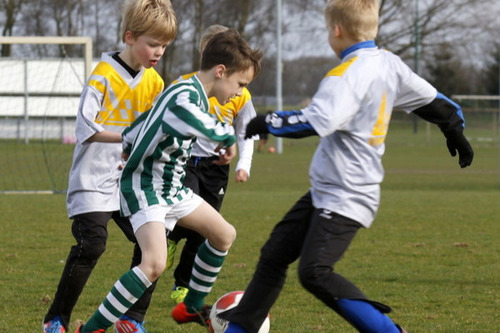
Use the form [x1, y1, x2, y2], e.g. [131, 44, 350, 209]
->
[200, 28, 262, 78]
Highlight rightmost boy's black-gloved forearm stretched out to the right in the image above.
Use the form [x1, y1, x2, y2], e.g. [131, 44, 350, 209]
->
[413, 93, 474, 168]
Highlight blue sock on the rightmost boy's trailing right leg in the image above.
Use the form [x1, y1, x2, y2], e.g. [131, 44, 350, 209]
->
[337, 298, 400, 333]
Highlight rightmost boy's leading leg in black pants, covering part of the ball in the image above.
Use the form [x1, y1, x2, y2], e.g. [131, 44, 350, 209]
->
[219, 193, 314, 333]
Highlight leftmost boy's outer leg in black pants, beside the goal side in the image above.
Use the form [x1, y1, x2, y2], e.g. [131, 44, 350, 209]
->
[44, 212, 112, 329]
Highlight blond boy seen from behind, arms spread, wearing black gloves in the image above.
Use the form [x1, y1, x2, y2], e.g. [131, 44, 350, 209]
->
[220, 0, 473, 333]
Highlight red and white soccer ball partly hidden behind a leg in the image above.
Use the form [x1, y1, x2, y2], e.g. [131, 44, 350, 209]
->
[209, 291, 270, 333]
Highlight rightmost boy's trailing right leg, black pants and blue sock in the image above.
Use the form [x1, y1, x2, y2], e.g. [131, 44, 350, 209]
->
[299, 209, 399, 333]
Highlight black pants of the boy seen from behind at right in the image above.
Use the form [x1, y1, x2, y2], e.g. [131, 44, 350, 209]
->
[220, 193, 372, 333]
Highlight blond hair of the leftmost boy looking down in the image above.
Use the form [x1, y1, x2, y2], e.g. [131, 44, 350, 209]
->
[121, 0, 177, 43]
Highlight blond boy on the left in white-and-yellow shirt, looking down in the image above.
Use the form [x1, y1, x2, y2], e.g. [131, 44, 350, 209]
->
[42, 0, 177, 333]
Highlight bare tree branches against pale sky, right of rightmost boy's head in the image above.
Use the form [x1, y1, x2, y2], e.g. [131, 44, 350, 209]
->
[377, 0, 500, 67]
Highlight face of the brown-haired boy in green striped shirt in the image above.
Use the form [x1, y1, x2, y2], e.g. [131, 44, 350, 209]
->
[213, 67, 254, 105]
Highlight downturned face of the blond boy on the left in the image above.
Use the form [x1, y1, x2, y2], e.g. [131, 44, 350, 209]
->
[129, 35, 168, 70]
